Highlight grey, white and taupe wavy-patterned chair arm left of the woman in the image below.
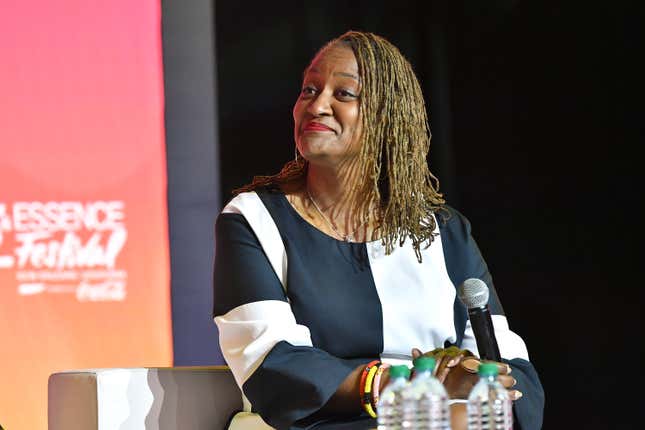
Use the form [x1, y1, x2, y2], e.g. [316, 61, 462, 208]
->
[48, 366, 242, 430]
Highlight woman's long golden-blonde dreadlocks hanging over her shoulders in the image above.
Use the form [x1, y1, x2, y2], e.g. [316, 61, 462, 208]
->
[234, 31, 445, 262]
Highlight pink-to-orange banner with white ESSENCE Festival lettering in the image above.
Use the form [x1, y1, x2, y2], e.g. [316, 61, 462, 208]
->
[0, 0, 172, 430]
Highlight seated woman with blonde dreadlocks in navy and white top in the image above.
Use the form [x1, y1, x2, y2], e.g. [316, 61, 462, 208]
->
[214, 32, 544, 429]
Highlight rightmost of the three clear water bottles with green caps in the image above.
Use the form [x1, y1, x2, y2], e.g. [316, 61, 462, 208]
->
[467, 363, 513, 430]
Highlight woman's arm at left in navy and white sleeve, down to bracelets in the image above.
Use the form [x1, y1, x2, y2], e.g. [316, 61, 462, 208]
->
[214, 214, 370, 428]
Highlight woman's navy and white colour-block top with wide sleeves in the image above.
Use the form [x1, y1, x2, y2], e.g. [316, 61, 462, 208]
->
[214, 191, 544, 429]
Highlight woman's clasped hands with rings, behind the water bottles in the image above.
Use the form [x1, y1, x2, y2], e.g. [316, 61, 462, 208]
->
[412, 346, 522, 400]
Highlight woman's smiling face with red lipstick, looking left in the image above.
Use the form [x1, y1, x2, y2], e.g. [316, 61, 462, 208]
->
[293, 45, 361, 166]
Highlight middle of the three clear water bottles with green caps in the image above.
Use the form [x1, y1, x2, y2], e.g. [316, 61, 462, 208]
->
[403, 357, 450, 430]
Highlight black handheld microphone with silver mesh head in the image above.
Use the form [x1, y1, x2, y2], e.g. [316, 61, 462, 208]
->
[457, 278, 502, 361]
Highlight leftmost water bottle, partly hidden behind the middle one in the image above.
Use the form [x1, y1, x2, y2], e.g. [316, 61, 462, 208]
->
[376, 365, 410, 430]
